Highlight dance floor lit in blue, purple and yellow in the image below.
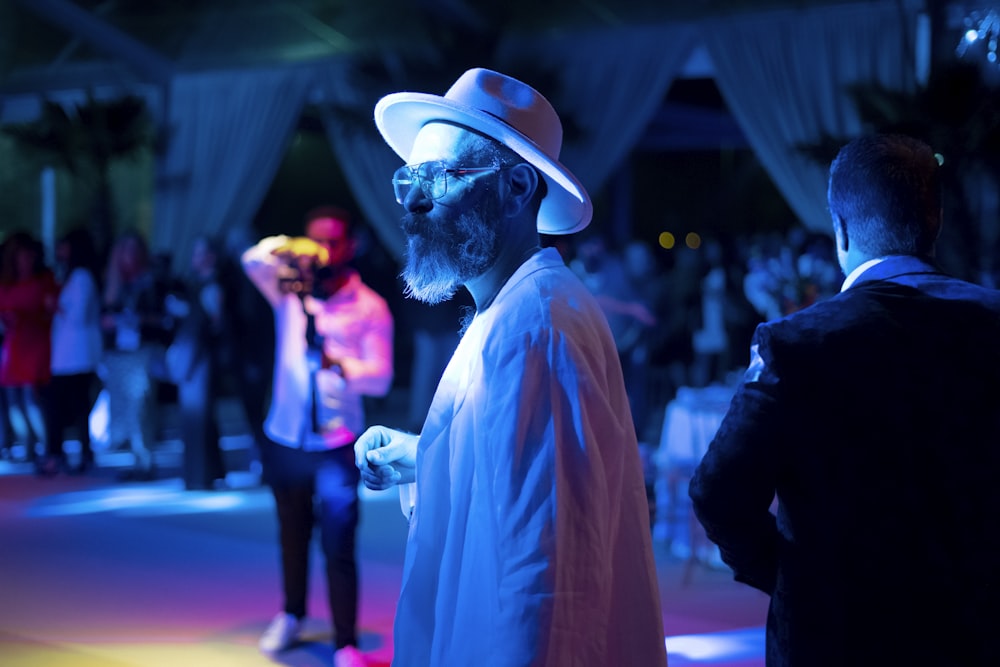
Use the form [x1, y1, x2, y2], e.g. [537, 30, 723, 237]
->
[0, 400, 767, 667]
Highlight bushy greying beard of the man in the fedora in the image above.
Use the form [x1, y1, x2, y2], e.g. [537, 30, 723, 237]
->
[402, 212, 499, 305]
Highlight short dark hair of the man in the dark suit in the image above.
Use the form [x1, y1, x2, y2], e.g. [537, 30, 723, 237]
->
[827, 134, 941, 256]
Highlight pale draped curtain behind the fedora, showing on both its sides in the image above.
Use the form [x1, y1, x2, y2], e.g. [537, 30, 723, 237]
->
[322, 25, 697, 257]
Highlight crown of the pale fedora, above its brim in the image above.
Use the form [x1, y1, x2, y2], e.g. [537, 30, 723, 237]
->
[445, 68, 562, 160]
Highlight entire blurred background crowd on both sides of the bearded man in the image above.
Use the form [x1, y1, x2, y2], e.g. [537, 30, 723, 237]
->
[0, 222, 843, 482]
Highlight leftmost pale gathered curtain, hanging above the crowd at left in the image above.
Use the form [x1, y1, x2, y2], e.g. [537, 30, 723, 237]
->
[151, 67, 314, 272]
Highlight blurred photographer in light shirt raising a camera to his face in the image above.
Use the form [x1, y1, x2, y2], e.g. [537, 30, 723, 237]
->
[237, 207, 393, 667]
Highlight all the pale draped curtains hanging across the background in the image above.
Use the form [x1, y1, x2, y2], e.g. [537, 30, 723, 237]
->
[146, 0, 915, 269]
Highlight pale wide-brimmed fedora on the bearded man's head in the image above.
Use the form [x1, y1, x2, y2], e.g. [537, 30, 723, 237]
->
[375, 69, 593, 234]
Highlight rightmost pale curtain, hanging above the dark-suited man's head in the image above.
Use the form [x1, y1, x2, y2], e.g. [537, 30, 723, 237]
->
[702, 2, 916, 232]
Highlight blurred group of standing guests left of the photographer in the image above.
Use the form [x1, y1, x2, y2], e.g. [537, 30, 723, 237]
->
[0, 228, 272, 489]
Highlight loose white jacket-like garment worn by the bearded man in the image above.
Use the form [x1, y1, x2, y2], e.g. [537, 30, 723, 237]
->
[393, 249, 666, 667]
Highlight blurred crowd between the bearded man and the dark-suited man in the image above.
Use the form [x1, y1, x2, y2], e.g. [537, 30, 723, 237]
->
[559, 224, 843, 443]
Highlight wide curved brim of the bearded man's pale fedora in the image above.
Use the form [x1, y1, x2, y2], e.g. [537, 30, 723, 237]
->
[375, 93, 593, 234]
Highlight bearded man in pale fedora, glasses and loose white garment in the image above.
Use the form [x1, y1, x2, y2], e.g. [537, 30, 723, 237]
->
[355, 69, 666, 667]
